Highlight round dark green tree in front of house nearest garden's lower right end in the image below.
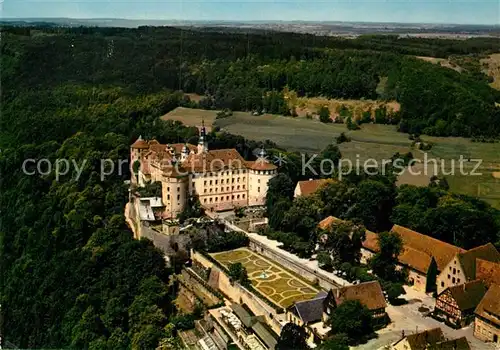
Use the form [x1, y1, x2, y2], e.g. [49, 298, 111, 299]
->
[328, 300, 373, 342]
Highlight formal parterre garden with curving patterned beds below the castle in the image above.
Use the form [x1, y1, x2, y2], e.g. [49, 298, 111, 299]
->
[212, 248, 319, 308]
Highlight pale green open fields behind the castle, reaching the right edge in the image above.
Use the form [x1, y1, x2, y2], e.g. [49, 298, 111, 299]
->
[165, 108, 500, 208]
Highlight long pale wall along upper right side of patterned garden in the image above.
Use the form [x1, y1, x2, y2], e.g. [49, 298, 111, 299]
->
[249, 237, 339, 290]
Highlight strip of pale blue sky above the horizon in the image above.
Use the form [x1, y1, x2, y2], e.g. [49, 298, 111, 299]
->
[0, 0, 500, 25]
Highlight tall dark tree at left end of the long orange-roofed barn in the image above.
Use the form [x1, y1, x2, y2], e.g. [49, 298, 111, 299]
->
[370, 232, 403, 281]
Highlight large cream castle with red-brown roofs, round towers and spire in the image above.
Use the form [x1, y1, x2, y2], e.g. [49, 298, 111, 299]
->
[130, 125, 277, 221]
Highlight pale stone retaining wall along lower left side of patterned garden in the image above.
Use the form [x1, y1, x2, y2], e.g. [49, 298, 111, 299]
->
[191, 251, 283, 334]
